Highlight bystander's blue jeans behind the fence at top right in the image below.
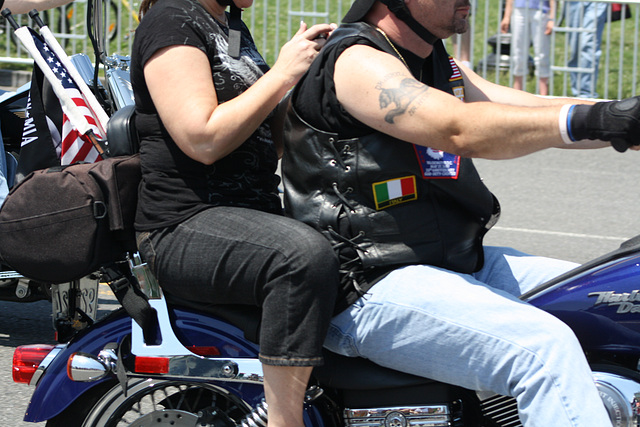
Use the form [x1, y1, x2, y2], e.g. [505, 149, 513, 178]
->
[566, 2, 608, 98]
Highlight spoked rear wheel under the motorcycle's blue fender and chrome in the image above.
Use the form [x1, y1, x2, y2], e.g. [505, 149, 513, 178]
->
[83, 378, 251, 427]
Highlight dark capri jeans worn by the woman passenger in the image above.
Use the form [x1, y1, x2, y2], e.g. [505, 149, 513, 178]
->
[138, 206, 339, 366]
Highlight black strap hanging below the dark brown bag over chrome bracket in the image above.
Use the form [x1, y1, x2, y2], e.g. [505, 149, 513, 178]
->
[100, 262, 162, 345]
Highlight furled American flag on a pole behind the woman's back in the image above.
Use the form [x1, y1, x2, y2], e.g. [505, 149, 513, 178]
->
[16, 27, 105, 165]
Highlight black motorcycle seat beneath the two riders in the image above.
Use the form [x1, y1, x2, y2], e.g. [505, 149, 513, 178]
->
[165, 293, 436, 390]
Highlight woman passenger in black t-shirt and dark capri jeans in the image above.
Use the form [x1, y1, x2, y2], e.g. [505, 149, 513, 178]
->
[131, 0, 339, 427]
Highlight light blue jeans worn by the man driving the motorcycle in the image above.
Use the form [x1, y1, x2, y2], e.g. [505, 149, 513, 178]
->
[325, 247, 611, 427]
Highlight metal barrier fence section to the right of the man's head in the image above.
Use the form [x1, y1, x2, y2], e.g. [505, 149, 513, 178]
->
[450, 0, 640, 99]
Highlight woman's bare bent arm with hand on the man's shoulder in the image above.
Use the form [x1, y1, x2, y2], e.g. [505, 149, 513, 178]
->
[144, 24, 334, 164]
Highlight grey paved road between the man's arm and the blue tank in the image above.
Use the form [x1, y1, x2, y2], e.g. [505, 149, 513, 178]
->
[476, 149, 640, 263]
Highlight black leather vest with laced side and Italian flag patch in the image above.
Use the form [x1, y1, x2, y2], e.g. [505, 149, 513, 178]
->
[282, 23, 499, 273]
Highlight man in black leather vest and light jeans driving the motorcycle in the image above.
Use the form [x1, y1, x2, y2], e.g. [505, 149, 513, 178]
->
[282, 0, 640, 426]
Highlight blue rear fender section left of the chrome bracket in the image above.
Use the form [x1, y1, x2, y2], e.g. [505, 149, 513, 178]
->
[24, 310, 131, 423]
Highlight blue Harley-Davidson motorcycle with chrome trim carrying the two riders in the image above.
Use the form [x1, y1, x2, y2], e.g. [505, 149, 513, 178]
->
[13, 226, 640, 427]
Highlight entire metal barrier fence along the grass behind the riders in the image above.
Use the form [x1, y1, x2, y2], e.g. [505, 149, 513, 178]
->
[0, 0, 640, 99]
